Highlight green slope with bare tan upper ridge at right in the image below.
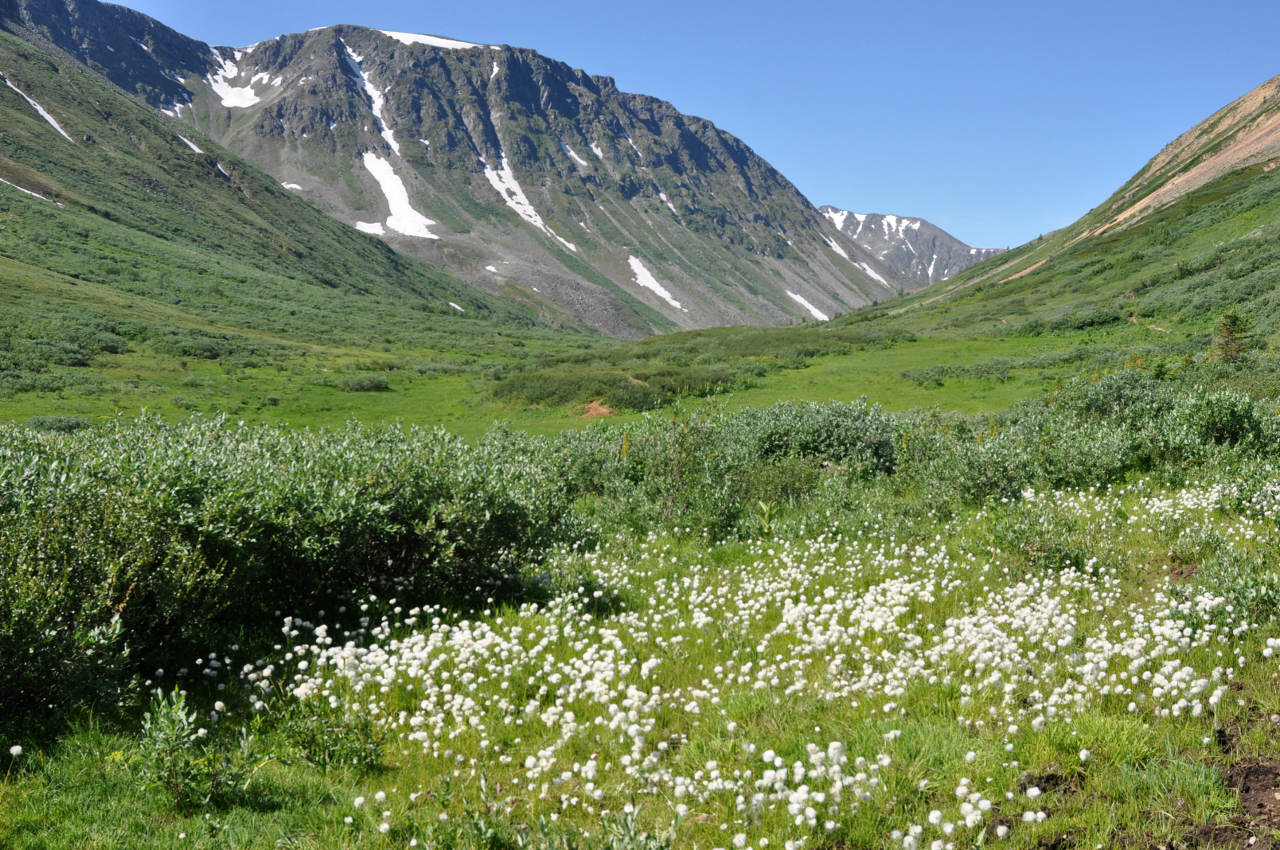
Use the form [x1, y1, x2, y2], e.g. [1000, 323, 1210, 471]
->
[870, 71, 1280, 338]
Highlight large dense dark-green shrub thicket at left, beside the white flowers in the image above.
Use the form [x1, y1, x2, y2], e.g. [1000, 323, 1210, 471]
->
[0, 419, 581, 732]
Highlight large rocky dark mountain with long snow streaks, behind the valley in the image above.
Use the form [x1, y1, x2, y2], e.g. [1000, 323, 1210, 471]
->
[4, 0, 922, 337]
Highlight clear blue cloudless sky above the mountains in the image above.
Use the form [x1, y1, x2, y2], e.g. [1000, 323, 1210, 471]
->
[117, 0, 1280, 248]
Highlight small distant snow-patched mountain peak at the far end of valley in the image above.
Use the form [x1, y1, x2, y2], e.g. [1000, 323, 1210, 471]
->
[819, 206, 1000, 288]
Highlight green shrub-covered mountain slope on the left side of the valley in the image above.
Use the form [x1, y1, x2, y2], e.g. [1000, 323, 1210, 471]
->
[0, 18, 550, 394]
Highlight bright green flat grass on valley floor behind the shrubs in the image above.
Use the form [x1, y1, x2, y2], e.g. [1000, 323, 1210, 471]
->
[0, 320, 1176, 437]
